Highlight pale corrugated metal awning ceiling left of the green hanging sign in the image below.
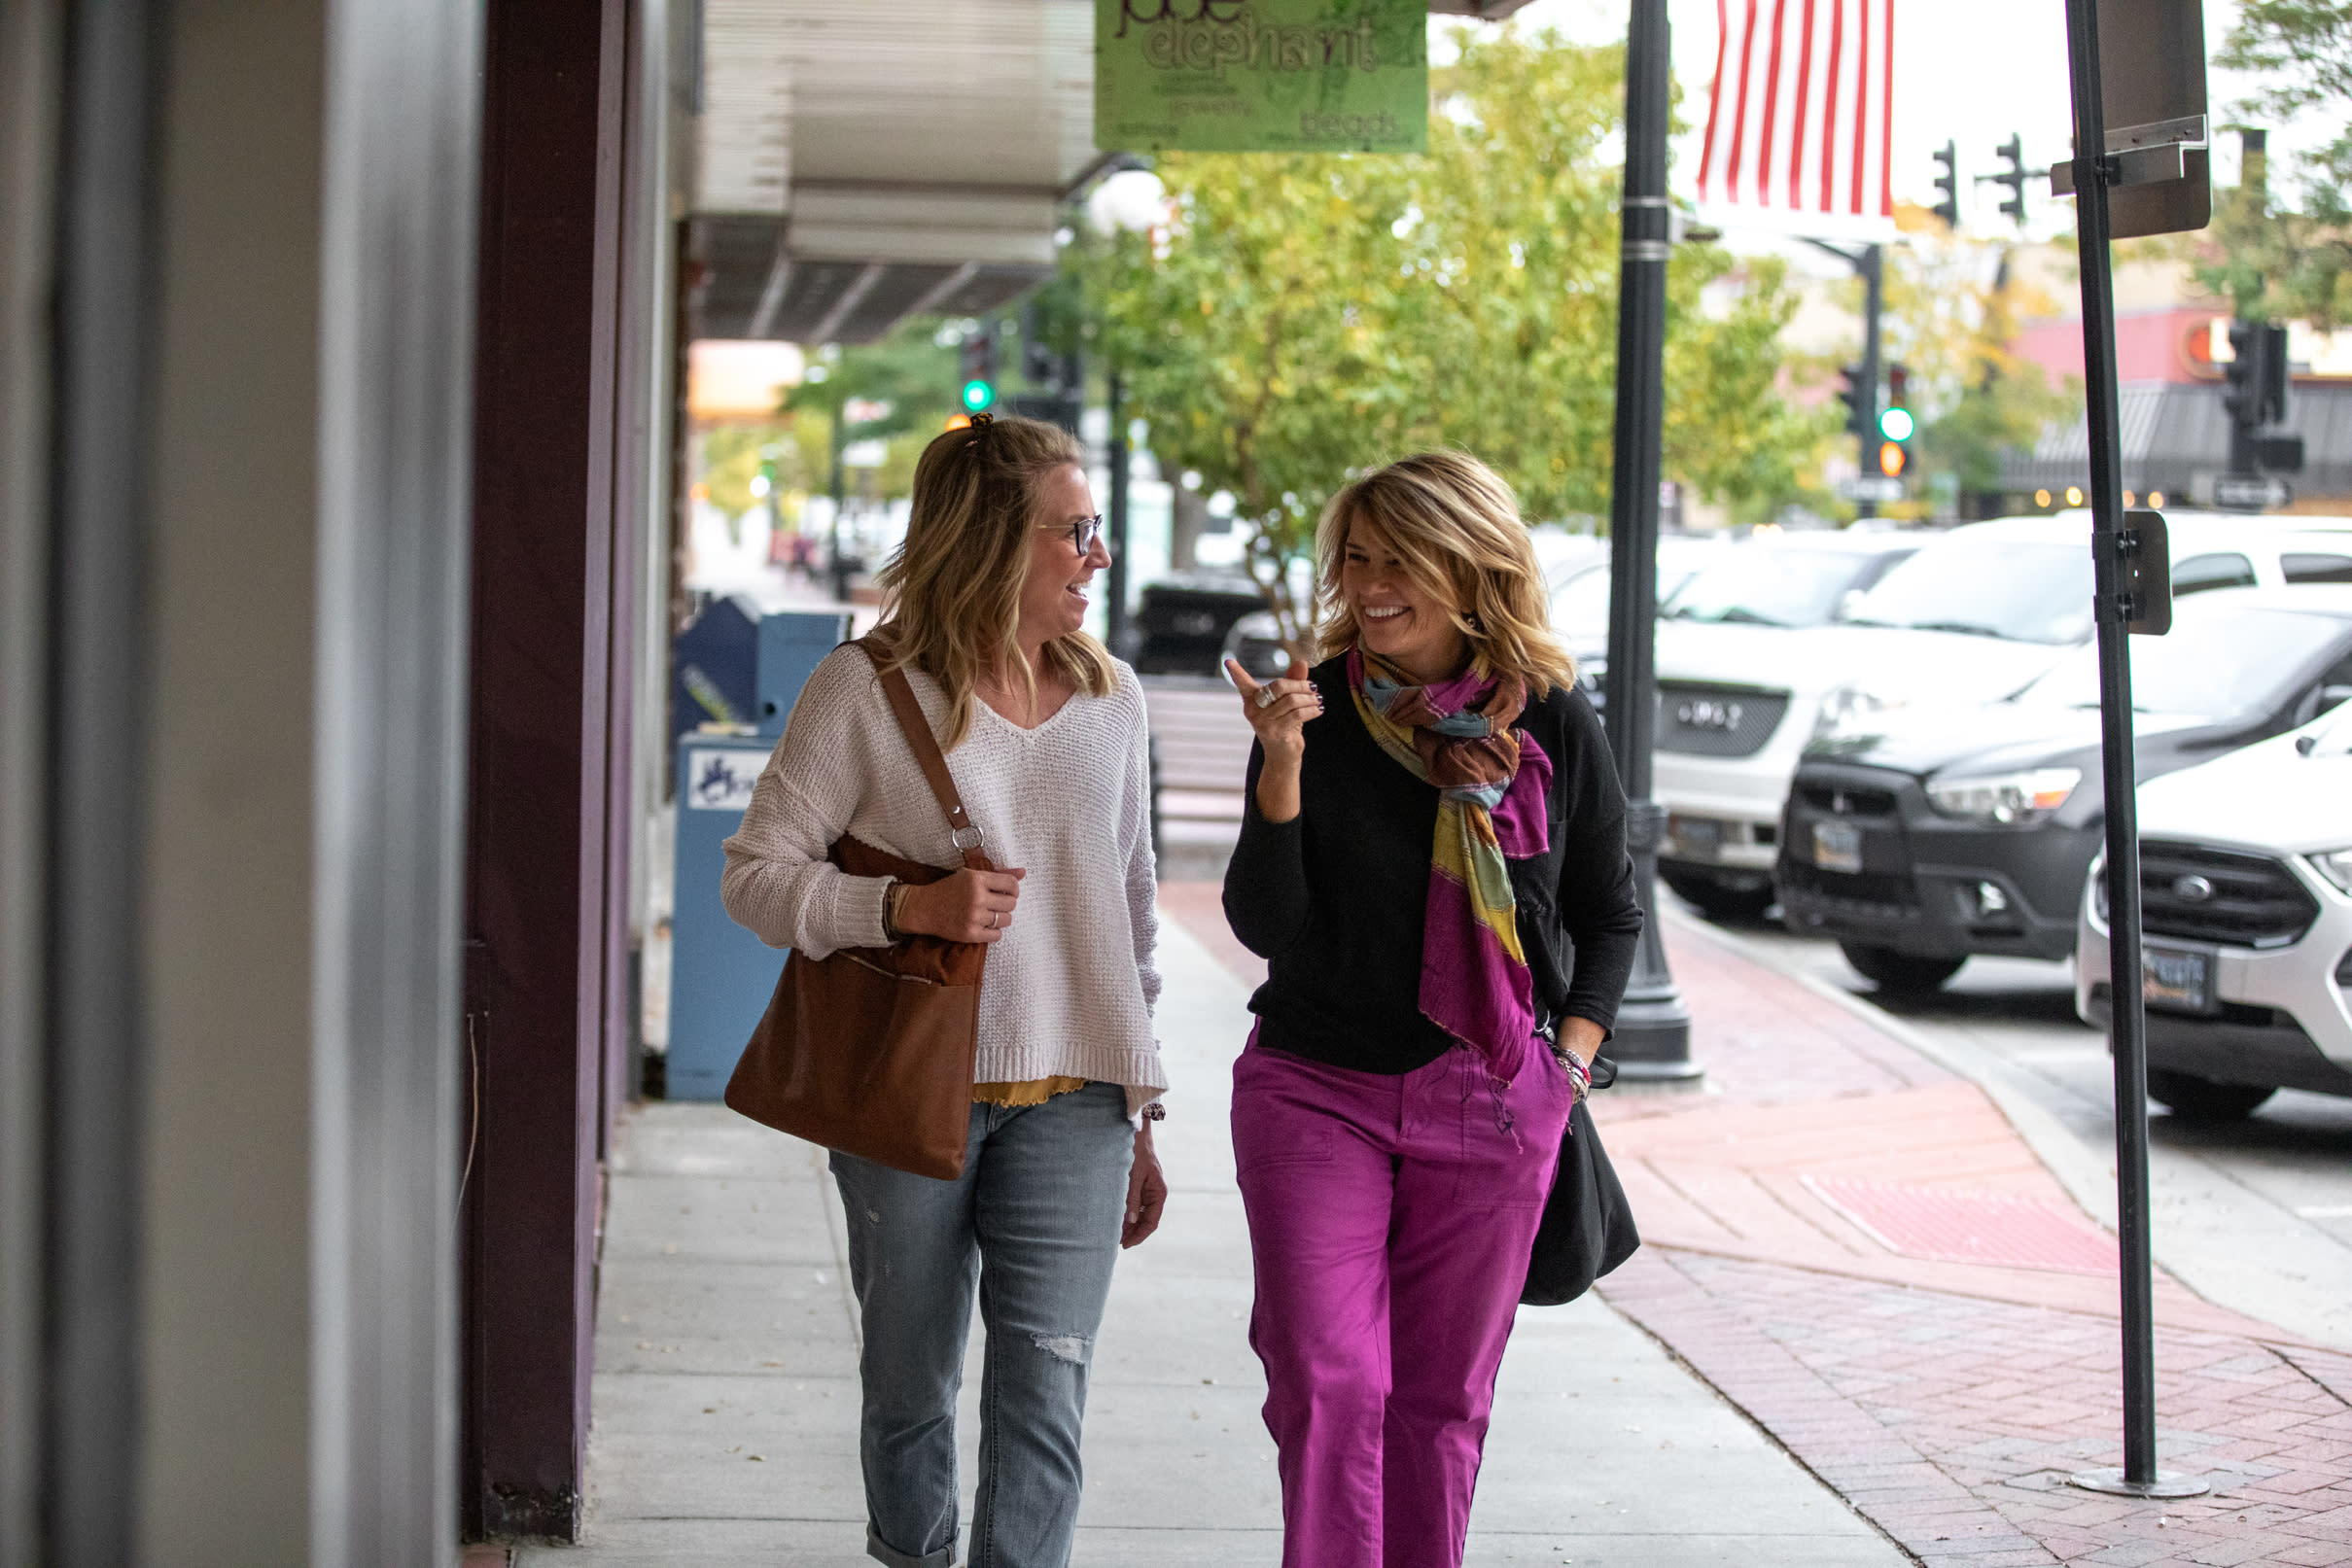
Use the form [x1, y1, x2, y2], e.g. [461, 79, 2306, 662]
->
[689, 0, 1525, 343]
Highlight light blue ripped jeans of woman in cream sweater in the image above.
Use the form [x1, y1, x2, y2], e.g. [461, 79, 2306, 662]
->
[832, 1084, 1136, 1568]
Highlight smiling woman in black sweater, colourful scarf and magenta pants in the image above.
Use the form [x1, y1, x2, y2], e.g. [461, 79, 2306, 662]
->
[1225, 454, 1641, 1568]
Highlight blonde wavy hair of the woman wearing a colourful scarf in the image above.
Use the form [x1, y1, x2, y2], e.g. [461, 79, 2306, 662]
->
[1315, 451, 1576, 701]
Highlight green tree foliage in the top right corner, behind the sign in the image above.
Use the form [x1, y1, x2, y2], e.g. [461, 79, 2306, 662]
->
[2185, 0, 2352, 330]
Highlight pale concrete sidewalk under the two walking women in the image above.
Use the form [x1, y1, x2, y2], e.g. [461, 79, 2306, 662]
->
[522, 920, 1908, 1568]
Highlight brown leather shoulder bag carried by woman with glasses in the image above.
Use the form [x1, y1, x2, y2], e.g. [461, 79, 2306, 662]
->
[726, 645, 995, 1180]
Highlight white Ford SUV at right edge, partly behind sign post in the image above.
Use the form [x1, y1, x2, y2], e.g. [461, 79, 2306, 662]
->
[2075, 705, 2352, 1119]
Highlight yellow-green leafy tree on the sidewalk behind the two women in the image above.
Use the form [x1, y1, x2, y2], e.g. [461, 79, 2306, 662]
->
[1072, 26, 1835, 637]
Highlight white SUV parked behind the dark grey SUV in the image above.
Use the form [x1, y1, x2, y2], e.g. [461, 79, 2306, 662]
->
[1651, 510, 2352, 915]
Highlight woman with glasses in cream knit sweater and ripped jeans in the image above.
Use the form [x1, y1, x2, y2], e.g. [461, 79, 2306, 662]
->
[722, 414, 1167, 1568]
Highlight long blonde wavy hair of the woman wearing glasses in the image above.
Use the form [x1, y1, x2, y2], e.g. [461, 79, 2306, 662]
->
[865, 418, 1117, 749]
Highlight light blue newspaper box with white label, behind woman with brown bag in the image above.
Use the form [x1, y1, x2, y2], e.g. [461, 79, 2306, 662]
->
[666, 613, 847, 1100]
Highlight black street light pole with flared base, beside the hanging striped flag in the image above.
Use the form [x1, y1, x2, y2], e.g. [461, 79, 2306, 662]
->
[1604, 0, 1701, 1079]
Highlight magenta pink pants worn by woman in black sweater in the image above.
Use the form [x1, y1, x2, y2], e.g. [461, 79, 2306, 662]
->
[1233, 1044, 1571, 1568]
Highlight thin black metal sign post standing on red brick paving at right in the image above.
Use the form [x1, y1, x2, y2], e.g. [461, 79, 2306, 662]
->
[2054, 0, 2206, 1497]
